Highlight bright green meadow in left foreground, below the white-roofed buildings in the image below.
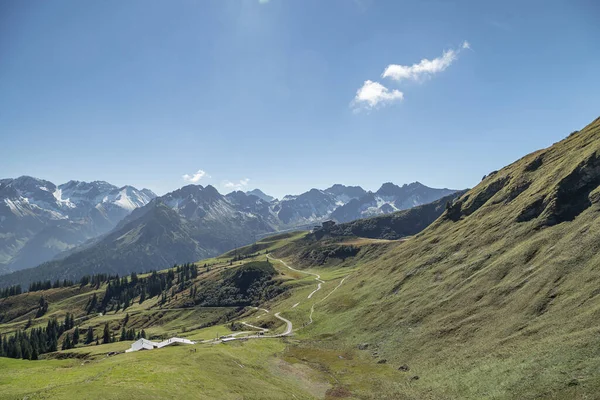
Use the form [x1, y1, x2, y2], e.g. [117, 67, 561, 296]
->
[0, 340, 329, 399]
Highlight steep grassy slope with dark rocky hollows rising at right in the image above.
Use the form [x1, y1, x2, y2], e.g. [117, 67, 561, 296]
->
[284, 115, 600, 399]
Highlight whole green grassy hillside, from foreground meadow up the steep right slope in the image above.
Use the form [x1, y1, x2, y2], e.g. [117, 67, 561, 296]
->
[0, 119, 600, 399]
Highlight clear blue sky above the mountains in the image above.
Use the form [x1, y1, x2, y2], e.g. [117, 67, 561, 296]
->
[0, 0, 600, 196]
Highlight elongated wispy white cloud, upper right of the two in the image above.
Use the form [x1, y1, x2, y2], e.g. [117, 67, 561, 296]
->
[381, 40, 471, 81]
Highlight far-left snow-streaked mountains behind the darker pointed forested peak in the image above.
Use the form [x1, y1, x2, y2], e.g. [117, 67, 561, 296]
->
[0, 176, 156, 273]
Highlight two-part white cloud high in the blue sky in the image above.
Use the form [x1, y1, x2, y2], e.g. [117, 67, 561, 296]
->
[350, 40, 471, 112]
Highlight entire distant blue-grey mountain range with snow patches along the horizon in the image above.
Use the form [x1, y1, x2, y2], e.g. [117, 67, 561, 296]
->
[0, 177, 455, 286]
